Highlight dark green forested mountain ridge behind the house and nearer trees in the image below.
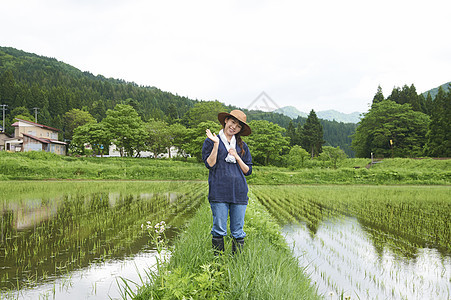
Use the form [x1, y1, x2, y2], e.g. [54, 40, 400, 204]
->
[0, 47, 355, 156]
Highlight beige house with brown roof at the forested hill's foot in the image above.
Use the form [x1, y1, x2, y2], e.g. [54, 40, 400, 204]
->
[4, 118, 67, 155]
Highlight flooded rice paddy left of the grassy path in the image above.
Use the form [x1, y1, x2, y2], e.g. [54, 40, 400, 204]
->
[0, 182, 207, 299]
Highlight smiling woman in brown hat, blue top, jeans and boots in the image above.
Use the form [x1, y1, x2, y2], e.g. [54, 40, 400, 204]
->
[202, 110, 252, 255]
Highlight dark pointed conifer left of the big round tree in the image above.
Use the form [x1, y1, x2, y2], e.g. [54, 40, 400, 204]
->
[301, 109, 324, 157]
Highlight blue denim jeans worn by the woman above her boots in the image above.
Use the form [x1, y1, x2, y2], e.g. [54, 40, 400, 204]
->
[210, 202, 247, 239]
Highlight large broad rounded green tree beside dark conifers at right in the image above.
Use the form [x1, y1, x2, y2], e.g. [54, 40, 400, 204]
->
[352, 100, 429, 157]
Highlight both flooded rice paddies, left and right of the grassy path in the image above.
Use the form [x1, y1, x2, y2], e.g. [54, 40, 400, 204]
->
[0, 181, 451, 299]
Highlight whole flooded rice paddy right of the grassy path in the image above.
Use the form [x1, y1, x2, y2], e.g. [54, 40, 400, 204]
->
[252, 186, 451, 299]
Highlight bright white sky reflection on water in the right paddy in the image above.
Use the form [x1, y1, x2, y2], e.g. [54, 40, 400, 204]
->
[283, 217, 451, 299]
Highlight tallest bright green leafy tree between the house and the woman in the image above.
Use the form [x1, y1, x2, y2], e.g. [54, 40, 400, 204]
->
[102, 104, 147, 156]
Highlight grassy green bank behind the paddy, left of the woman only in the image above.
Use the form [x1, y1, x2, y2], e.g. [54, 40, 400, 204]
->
[0, 152, 208, 180]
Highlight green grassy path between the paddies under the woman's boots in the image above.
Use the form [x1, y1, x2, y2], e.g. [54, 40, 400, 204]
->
[135, 200, 320, 299]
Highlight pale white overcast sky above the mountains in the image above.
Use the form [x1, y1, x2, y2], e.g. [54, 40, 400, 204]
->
[0, 0, 451, 113]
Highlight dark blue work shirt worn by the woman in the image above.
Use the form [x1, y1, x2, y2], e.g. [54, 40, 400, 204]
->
[202, 138, 252, 204]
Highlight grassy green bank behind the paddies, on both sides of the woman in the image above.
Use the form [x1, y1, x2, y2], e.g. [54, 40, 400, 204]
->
[0, 152, 451, 185]
